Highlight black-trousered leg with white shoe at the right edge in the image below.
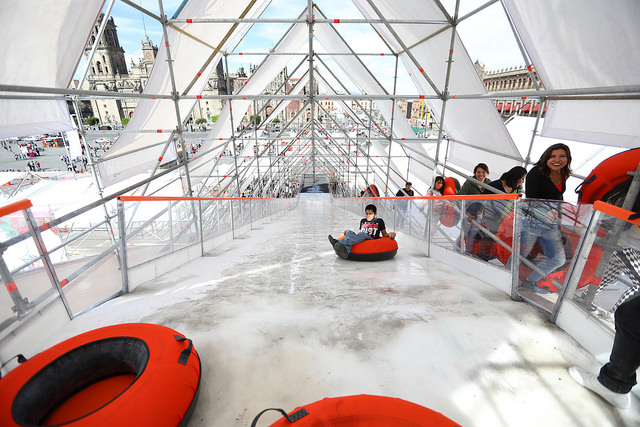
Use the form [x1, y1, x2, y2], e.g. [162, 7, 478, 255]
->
[569, 297, 640, 409]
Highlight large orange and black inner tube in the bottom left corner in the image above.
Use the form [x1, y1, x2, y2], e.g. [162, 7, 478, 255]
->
[0, 323, 200, 427]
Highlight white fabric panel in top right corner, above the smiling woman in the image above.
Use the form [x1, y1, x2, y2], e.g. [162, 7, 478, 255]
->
[504, 0, 640, 148]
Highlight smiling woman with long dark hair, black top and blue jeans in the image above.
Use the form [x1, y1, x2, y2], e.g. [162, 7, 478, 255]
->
[520, 143, 571, 294]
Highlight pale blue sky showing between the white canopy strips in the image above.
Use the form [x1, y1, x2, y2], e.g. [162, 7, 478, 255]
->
[79, 0, 524, 94]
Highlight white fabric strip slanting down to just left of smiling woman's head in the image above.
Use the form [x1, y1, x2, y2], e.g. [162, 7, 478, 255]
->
[354, 0, 521, 177]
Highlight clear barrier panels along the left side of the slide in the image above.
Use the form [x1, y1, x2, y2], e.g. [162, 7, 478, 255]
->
[0, 197, 297, 331]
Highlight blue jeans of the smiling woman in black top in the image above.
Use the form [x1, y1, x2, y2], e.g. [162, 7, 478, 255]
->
[520, 218, 567, 283]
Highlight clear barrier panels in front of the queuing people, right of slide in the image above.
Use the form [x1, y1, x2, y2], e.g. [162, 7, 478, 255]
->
[334, 195, 604, 314]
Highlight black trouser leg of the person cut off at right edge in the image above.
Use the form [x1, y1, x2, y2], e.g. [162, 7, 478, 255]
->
[598, 297, 640, 393]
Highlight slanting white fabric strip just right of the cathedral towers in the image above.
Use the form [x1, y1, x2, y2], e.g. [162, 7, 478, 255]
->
[98, 0, 269, 185]
